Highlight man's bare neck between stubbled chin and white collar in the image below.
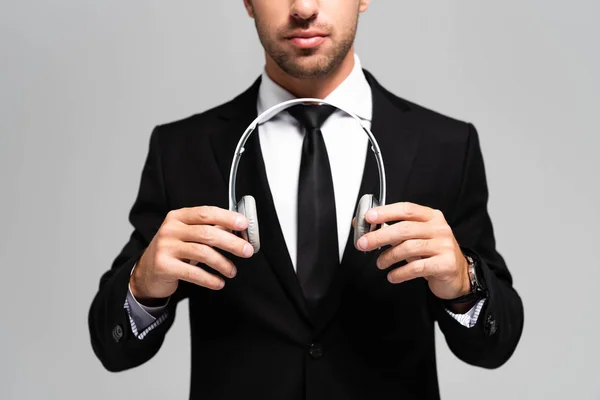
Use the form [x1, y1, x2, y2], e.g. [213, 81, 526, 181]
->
[265, 46, 354, 99]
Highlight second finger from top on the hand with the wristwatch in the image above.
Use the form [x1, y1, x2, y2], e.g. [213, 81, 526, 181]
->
[357, 221, 435, 251]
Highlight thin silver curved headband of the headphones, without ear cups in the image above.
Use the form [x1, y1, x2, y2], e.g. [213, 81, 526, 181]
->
[229, 98, 386, 211]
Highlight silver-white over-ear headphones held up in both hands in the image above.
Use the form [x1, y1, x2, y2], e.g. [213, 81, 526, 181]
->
[229, 98, 386, 254]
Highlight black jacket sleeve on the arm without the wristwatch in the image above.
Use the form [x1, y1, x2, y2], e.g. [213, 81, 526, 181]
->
[88, 128, 184, 372]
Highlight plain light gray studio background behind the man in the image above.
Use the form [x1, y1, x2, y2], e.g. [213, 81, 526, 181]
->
[0, 0, 600, 400]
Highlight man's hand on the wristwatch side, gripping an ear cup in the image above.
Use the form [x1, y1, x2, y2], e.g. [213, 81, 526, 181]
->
[356, 202, 470, 299]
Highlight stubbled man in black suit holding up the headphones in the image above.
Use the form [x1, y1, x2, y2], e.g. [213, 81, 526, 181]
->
[89, 0, 523, 399]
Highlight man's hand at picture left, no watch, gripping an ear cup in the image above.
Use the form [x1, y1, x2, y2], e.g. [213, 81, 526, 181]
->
[130, 206, 254, 305]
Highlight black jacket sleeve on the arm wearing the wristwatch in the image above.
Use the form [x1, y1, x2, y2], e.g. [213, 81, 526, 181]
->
[432, 124, 524, 368]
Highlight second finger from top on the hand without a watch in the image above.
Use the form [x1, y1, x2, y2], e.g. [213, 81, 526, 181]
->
[181, 225, 254, 258]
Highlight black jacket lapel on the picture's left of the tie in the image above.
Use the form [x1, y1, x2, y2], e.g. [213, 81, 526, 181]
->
[211, 78, 310, 322]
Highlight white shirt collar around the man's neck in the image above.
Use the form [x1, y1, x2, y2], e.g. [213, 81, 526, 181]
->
[257, 54, 373, 122]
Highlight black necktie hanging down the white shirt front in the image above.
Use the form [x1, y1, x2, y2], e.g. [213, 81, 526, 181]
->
[288, 104, 339, 310]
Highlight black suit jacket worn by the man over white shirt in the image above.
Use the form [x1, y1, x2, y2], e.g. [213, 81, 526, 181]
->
[89, 71, 523, 400]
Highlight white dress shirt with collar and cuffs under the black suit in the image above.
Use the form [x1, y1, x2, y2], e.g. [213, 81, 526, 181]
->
[125, 55, 485, 339]
